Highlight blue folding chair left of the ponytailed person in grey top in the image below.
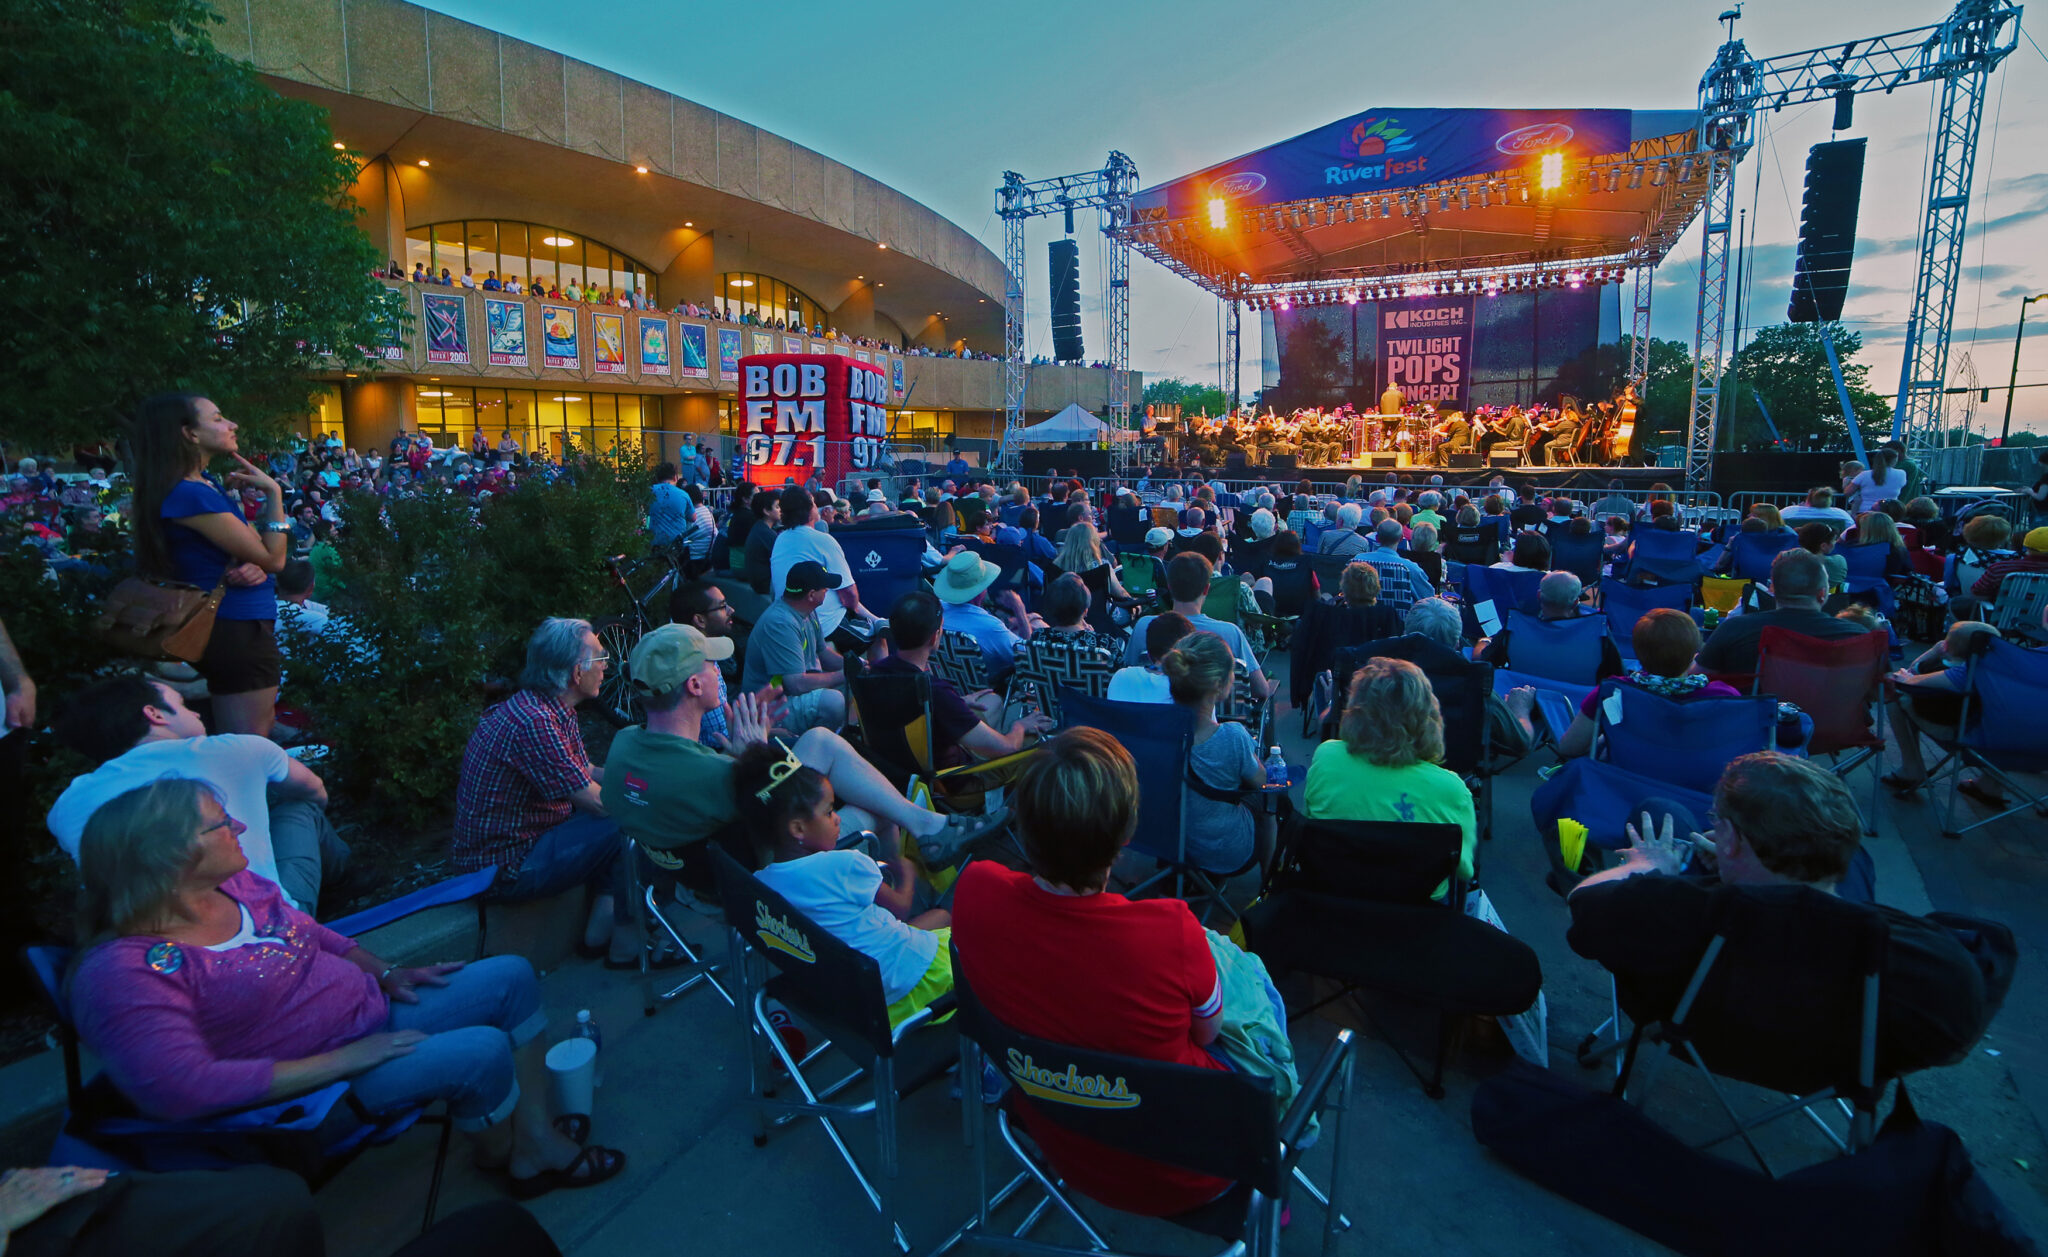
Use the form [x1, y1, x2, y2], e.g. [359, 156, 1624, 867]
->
[1059, 690, 1257, 921]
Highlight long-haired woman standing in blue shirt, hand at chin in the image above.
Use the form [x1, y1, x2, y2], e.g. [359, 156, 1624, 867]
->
[135, 393, 291, 737]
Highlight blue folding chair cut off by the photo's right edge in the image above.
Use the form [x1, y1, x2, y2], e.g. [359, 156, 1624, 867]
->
[1896, 634, 2048, 837]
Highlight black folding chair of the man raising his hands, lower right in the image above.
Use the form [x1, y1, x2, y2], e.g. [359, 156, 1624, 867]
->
[1595, 886, 1896, 1173]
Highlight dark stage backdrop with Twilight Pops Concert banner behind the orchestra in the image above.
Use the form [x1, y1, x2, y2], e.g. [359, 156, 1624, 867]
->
[1260, 285, 1626, 414]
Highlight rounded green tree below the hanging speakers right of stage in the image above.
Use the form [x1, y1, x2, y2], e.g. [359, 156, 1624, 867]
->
[1720, 323, 1892, 448]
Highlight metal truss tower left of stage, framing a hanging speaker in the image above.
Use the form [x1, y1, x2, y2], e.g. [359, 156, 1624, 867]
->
[995, 151, 1139, 475]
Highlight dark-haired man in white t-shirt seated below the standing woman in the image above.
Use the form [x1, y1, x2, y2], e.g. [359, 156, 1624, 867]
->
[45, 674, 348, 913]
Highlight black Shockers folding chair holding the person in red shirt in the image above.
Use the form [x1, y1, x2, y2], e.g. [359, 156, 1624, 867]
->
[934, 956, 1352, 1257]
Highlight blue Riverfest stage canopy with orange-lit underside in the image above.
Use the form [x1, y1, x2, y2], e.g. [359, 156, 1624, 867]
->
[1128, 109, 1708, 305]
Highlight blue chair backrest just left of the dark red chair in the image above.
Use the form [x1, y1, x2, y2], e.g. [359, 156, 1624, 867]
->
[1595, 680, 1778, 794]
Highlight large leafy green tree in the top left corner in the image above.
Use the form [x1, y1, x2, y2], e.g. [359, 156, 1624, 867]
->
[0, 0, 391, 450]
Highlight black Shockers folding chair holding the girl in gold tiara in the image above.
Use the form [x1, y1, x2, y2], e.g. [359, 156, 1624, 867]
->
[711, 850, 958, 1253]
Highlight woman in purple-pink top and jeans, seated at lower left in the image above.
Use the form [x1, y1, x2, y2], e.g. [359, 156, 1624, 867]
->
[68, 778, 625, 1198]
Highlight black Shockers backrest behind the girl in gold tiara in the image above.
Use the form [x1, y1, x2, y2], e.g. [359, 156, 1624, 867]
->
[711, 850, 893, 1056]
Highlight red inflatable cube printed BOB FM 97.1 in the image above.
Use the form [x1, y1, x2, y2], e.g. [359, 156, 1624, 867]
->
[739, 354, 889, 487]
